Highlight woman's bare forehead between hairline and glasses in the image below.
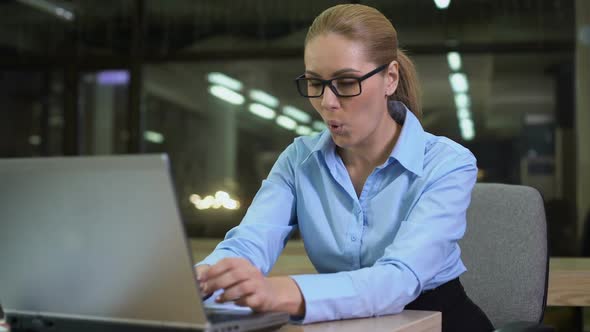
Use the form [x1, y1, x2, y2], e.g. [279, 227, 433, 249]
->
[304, 33, 371, 75]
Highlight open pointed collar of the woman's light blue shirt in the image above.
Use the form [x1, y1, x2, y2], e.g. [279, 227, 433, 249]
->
[303, 101, 426, 176]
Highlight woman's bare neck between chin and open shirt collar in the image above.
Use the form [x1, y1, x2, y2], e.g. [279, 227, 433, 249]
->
[337, 112, 401, 168]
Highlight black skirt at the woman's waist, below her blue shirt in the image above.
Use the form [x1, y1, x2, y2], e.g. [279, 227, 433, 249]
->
[406, 278, 494, 332]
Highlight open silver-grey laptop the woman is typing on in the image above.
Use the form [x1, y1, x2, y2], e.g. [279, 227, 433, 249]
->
[0, 155, 289, 332]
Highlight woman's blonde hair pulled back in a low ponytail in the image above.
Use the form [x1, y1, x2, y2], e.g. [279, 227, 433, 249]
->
[305, 4, 422, 119]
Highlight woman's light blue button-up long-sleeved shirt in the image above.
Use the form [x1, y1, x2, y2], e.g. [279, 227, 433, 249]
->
[199, 107, 477, 323]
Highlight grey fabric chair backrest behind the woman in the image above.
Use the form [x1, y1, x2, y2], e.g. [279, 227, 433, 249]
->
[460, 183, 549, 328]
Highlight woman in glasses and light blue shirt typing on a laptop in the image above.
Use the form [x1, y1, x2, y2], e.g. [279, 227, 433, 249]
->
[196, 5, 493, 332]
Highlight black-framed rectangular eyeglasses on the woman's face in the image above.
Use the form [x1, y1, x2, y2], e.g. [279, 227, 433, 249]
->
[295, 64, 388, 98]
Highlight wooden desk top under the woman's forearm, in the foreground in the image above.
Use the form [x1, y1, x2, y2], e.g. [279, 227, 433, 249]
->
[279, 310, 442, 332]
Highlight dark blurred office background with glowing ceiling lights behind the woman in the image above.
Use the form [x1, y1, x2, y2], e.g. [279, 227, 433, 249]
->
[0, 0, 590, 326]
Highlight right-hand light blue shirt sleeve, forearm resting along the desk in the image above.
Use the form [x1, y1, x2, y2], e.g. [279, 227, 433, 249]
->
[291, 152, 477, 324]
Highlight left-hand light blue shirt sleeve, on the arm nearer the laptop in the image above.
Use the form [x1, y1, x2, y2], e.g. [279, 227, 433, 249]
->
[196, 143, 297, 275]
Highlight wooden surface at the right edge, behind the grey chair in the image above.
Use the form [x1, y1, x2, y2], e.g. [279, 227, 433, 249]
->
[547, 257, 590, 307]
